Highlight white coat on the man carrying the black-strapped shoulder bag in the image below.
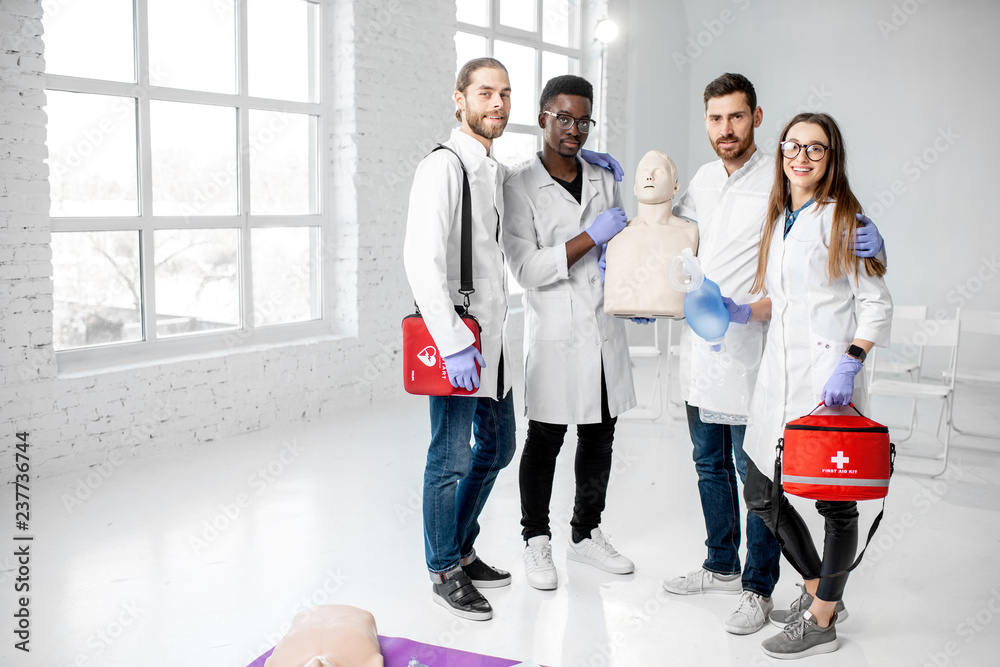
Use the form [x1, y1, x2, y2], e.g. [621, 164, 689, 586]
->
[403, 129, 511, 398]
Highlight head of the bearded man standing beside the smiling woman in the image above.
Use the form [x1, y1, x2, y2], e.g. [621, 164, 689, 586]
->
[705, 73, 764, 163]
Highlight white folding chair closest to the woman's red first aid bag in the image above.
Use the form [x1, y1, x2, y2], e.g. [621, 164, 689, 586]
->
[868, 319, 959, 477]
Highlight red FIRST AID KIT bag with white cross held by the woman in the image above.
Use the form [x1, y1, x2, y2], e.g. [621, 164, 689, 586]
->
[778, 403, 896, 500]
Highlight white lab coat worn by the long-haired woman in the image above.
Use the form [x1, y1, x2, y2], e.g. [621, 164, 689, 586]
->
[743, 203, 892, 477]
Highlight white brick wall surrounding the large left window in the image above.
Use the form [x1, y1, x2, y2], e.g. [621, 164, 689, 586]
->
[0, 0, 624, 479]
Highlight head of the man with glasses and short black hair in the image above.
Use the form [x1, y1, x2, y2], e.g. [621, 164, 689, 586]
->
[538, 74, 594, 158]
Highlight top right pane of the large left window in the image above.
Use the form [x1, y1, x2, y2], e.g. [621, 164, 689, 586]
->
[247, 0, 319, 102]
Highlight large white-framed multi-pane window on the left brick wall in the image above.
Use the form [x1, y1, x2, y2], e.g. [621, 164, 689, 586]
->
[43, 0, 332, 367]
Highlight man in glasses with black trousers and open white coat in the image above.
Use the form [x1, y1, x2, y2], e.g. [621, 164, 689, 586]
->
[503, 75, 636, 589]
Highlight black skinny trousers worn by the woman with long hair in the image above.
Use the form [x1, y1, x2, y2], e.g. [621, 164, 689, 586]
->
[743, 460, 858, 602]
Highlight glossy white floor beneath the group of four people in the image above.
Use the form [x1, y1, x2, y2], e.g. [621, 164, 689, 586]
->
[0, 378, 1000, 667]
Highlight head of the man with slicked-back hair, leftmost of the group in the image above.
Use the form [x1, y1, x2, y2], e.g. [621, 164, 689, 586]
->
[454, 58, 510, 147]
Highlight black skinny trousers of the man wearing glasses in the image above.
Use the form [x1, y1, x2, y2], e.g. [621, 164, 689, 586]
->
[518, 366, 618, 542]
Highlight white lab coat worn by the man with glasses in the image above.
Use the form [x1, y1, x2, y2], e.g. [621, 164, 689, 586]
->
[504, 157, 636, 424]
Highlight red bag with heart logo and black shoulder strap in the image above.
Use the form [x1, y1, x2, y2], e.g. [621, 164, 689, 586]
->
[403, 144, 483, 396]
